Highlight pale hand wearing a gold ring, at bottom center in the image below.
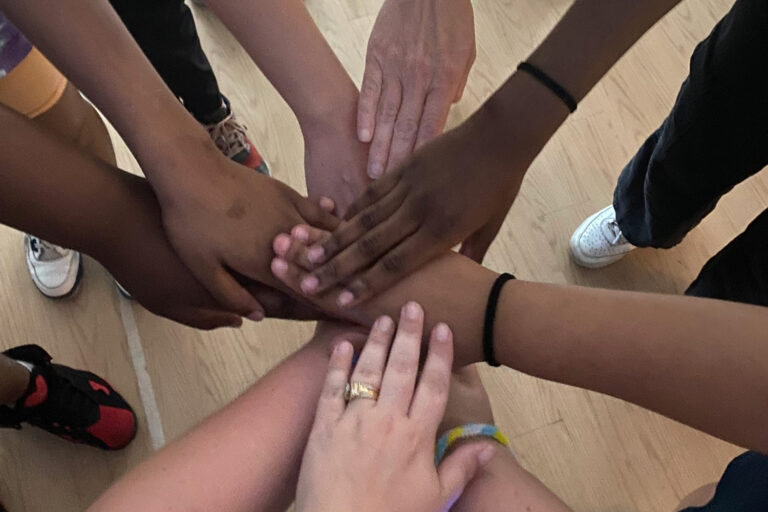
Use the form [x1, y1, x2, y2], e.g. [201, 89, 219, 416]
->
[296, 302, 495, 512]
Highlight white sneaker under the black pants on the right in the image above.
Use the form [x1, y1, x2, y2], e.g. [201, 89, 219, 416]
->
[571, 206, 636, 268]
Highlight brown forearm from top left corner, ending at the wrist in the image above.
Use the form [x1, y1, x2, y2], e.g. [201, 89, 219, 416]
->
[0, 0, 215, 188]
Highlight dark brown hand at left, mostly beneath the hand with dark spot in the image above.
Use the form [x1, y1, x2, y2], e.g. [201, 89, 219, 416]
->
[100, 174, 325, 329]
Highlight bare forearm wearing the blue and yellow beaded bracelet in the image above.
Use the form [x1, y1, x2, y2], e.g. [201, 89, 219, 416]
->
[440, 366, 571, 512]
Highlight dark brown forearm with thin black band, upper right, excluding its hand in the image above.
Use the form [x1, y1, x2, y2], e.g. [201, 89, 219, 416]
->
[475, 0, 680, 178]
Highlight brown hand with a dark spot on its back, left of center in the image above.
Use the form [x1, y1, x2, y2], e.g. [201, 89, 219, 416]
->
[155, 148, 337, 320]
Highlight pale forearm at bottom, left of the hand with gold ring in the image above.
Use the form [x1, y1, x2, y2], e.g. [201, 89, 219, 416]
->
[90, 336, 330, 512]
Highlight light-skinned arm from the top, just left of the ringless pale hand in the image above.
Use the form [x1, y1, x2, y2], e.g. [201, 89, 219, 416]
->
[207, 0, 369, 212]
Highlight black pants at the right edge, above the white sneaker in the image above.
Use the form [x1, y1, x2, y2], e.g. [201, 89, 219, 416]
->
[613, 0, 768, 306]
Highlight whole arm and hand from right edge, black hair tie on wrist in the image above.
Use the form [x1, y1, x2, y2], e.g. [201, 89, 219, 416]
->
[272, 231, 768, 451]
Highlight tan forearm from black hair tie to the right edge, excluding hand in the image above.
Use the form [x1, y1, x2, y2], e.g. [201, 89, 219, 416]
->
[496, 282, 768, 452]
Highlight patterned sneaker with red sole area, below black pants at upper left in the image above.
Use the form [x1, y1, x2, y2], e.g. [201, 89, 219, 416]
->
[203, 97, 269, 176]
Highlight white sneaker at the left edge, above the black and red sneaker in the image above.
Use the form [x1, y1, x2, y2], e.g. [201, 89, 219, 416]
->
[24, 235, 83, 299]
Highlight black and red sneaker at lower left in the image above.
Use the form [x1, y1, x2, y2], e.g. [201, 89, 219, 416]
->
[0, 345, 136, 450]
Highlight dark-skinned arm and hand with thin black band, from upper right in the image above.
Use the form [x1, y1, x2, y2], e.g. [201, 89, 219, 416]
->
[296, 0, 679, 301]
